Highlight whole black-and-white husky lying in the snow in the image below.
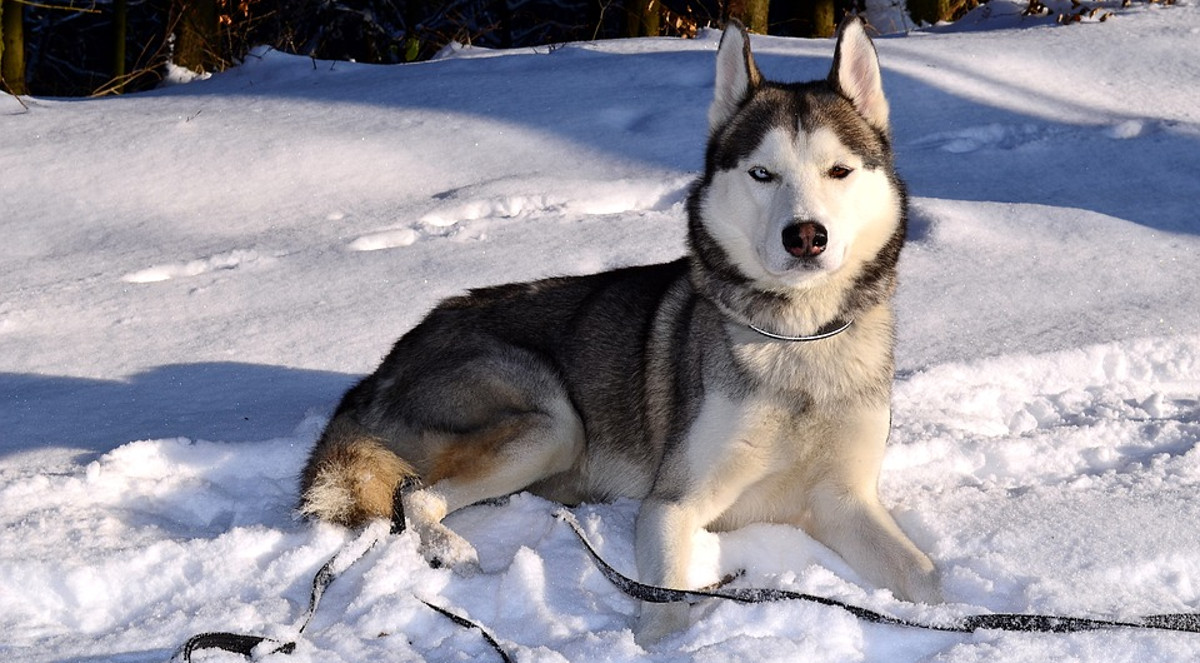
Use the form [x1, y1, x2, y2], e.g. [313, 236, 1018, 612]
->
[300, 19, 938, 643]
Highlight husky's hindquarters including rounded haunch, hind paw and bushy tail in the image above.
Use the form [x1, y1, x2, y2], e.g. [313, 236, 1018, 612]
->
[300, 336, 584, 572]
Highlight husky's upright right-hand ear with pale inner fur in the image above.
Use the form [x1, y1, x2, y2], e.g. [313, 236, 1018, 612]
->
[829, 17, 888, 132]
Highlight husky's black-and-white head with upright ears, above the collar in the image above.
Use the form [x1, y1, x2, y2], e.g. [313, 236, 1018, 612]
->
[689, 18, 905, 293]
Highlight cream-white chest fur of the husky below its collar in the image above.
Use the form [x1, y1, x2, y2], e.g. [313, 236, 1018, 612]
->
[686, 307, 892, 530]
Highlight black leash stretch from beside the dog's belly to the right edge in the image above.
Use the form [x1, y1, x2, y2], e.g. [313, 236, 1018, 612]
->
[554, 509, 1200, 633]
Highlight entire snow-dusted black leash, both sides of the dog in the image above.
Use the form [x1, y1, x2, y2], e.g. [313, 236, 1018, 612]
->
[173, 499, 1200, 663]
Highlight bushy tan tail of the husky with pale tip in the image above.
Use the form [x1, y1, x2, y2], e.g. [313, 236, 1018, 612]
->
[299, 416, 416, 527]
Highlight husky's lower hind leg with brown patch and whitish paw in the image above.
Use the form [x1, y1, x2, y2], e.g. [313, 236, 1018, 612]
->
[403, 395, 583, 573]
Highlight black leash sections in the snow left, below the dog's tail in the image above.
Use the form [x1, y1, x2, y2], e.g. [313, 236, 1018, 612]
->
[172, 479, 512, 663]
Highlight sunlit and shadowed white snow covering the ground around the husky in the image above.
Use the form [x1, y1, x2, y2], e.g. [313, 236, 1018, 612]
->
[0, 0, 1200, 663]
